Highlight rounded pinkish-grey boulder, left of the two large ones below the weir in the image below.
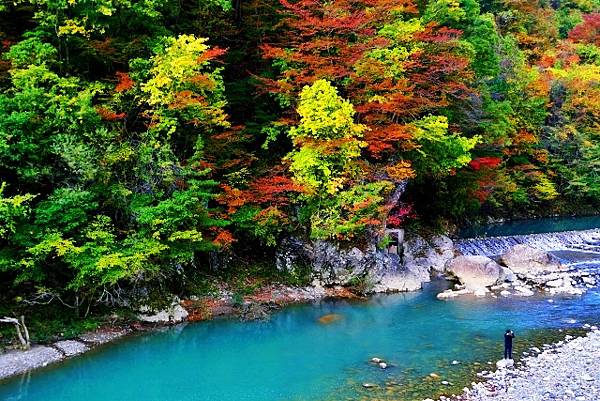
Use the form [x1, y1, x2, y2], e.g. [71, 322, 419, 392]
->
[446, 256, 503, 291]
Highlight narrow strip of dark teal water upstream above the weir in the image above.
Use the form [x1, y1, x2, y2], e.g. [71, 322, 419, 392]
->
[459, 216, 600, 238]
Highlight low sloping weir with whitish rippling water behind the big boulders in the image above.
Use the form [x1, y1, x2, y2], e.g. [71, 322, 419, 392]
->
[455, 229, 600, 258]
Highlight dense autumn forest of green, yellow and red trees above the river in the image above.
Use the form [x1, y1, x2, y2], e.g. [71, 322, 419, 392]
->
[0, 0, 600, 320]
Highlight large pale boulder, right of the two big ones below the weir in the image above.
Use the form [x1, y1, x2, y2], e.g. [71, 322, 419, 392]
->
[501, 244, 563, 276]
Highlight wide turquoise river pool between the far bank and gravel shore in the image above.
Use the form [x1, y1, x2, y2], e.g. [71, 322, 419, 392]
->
[0, 282, 600, 401]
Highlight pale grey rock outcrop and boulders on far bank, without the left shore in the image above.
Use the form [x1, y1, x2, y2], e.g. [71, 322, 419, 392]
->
[277, 233, 596, 298]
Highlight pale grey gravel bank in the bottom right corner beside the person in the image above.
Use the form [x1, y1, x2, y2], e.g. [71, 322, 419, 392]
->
[440, 330, 600, 401]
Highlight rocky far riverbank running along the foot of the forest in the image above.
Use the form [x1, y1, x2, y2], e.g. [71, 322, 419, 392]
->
[0, 228, 596, 379]
